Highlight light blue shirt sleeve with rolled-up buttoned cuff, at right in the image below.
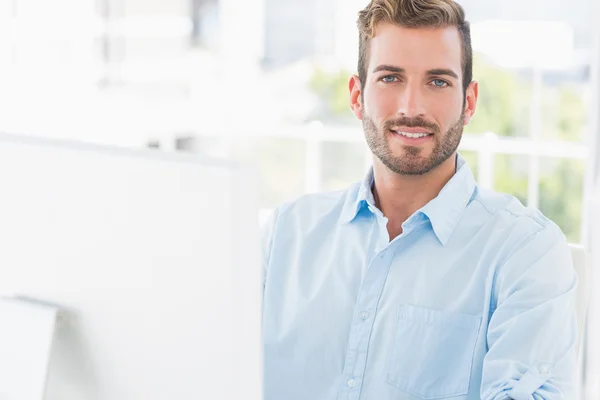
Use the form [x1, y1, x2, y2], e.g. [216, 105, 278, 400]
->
[481, 223, 578, 400]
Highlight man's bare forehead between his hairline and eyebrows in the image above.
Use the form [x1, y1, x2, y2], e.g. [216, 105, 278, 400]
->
[369, 23, 462, 76]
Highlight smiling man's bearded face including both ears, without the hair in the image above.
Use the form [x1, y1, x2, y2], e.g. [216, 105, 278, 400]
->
[350, 23, 477, 175]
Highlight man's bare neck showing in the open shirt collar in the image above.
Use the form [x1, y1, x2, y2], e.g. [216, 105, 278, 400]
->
[373, 154, 456, 240]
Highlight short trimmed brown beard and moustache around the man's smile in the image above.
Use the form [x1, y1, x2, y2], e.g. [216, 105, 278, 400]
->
[362, 111, 464, 175]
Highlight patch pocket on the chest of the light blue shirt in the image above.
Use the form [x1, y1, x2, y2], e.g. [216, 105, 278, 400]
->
[387, 305, 481, 399]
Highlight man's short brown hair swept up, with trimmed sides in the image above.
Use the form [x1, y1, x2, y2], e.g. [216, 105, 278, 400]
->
[357, 0, 473, 93]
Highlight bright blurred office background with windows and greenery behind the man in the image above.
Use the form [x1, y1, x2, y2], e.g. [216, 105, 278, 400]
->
[0, 0, 600, 399]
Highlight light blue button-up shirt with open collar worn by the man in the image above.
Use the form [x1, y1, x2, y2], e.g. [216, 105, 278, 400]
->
[263, 156, 578, 400]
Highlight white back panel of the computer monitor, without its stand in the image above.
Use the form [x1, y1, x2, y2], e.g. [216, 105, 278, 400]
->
[0, 134, 262, 400]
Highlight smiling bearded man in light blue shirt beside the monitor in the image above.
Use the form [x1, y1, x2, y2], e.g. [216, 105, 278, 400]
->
[264, 0, 578, 400]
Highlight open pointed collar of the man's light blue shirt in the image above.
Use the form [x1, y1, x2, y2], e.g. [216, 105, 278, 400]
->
[342, 154, 476, 245]
